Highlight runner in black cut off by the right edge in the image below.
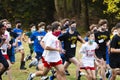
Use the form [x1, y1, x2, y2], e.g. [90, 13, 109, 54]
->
[110, 23, 120, 80]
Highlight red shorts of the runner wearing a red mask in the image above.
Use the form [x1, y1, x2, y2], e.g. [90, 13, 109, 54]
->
[41, 57, 62, 68]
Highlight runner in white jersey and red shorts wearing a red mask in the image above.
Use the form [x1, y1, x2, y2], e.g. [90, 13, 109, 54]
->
[27, 21, 66, 80]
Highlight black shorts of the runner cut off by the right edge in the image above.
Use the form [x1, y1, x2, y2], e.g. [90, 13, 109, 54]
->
[110, 54, 120, 69]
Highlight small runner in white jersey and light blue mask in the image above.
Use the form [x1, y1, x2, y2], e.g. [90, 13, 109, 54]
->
[79, 32, 98, 80]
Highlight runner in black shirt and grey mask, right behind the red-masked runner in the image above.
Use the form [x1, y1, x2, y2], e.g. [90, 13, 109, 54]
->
[58, 20, 85, 80]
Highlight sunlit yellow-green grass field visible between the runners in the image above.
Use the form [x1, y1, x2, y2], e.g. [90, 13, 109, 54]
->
[3, 43, 120, 80]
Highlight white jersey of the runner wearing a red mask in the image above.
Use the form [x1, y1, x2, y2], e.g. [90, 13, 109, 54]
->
[44, 34, 61, 62]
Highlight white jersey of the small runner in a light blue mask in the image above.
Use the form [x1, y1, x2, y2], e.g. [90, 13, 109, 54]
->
[79, 42, 97, 67]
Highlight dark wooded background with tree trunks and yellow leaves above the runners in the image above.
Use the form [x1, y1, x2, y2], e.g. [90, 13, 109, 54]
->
[0, 0, 120, 30]
